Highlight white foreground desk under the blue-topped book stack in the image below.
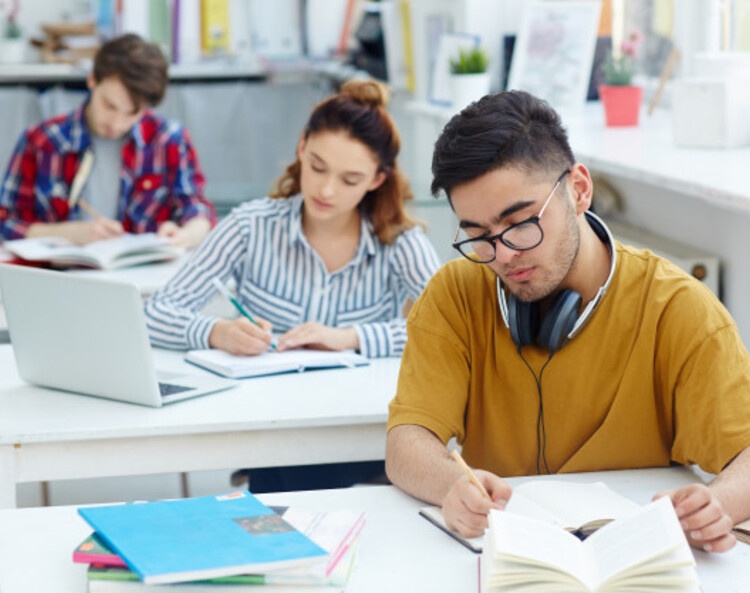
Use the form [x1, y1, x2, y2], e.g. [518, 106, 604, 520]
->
[0, 468, 750, 593]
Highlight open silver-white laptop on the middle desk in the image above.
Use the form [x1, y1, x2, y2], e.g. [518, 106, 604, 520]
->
[0, 264, 236, 407]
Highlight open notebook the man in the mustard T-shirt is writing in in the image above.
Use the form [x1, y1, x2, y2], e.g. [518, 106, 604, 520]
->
[419, 480, 641, 552]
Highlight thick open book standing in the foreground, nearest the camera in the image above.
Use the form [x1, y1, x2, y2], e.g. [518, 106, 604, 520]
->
[482, 497, 700, 593]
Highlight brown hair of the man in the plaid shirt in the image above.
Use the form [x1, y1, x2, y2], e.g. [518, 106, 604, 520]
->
[94, 33, 169, 109]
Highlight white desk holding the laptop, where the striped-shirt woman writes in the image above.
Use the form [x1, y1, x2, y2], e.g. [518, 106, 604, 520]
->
[0, 345, 400, 508]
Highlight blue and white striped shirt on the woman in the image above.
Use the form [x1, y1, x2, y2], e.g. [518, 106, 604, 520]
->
[145, 195, 440, 357]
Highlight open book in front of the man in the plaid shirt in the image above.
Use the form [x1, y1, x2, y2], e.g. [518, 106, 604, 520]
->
[5, 233, 184, 270]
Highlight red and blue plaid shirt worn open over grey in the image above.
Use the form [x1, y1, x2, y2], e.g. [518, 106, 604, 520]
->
[0, 103, 217, 239]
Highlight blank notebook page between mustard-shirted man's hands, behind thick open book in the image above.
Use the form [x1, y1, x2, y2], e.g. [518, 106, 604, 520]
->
[506, 480, 641, 529]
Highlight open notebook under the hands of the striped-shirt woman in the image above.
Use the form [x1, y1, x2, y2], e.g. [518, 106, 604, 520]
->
[185, 349, 370, 379]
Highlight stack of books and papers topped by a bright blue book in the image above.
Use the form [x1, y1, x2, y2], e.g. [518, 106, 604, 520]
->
[73, 492, 365, 593]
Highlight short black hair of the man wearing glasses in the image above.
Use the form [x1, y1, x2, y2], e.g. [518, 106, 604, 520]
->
[430, 90, 575, 199]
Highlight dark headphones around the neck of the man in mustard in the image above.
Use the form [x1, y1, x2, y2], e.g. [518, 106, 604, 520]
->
[497, 211, 617, 354]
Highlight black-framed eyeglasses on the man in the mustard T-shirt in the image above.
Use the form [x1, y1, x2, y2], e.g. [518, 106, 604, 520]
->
[453, 168, 571, 264]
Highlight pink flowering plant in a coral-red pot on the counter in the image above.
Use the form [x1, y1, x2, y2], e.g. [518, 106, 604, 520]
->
[599, 31, 643, 126]
